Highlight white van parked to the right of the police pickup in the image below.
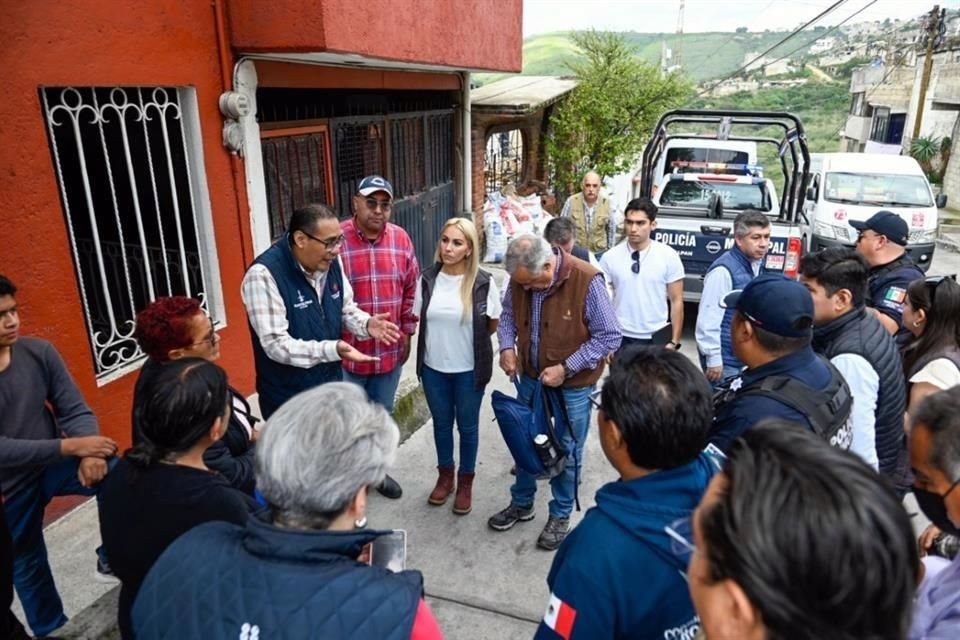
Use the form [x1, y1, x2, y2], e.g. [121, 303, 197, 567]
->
[801, 153, 947, 271]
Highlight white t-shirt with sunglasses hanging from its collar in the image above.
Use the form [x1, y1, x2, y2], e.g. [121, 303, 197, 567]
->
[600, 240, 684, 340]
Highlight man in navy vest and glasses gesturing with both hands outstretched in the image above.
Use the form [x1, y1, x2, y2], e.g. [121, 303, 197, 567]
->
[242, 204, 400, 418]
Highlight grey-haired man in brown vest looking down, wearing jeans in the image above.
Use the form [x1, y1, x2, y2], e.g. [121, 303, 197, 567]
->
[488, 235, 621, 551]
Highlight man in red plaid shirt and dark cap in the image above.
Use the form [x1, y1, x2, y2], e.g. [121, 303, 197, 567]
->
[340, 176, 420, 498]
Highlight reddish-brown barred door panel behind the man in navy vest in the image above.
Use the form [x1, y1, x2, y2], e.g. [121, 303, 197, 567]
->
[260, 125, 333, 240]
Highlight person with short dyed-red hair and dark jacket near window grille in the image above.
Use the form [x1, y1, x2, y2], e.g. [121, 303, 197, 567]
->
[133, 296, 258, 494]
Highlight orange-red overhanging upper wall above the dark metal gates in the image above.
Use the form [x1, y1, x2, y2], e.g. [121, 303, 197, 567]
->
[228, 0, 523, 72]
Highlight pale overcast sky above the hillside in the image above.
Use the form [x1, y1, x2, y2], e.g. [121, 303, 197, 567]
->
[523, 0, 960, 37]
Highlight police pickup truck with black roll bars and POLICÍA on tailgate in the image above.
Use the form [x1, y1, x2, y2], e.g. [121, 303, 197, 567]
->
[636, 110, 810, 302]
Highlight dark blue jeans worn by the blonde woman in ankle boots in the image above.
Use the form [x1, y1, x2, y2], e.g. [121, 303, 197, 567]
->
[420, 365, 483, 473]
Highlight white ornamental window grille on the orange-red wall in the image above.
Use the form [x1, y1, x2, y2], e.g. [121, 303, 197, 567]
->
[40, 87, 223, 385]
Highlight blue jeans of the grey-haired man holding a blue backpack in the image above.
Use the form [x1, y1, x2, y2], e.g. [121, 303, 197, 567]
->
[510, 375, 593, 518]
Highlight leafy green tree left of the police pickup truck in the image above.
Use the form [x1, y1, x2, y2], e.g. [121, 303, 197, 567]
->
[545, 30, 691, 191]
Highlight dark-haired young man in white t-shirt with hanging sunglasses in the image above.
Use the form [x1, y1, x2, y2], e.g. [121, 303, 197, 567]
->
[600, 198, 684, 349]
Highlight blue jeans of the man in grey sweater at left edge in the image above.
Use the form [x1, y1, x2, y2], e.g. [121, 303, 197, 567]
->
[3, 457, 116, 636]
